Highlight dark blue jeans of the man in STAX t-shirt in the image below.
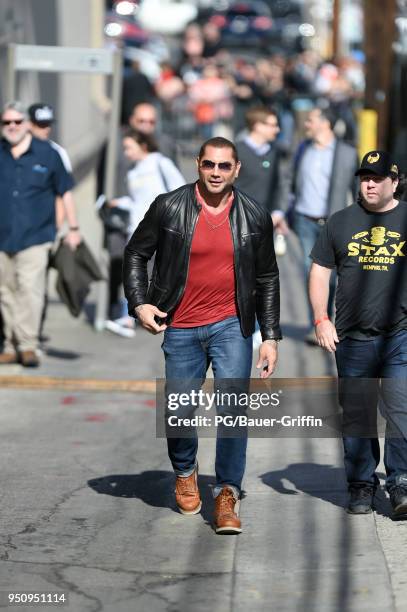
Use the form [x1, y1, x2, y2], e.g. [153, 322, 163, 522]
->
[336, 331, 407, 489]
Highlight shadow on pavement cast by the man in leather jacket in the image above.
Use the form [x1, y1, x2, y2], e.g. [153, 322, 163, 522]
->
[88, 470, 215, 523]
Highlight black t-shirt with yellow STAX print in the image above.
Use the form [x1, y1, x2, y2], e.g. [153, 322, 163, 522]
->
[310, 202, 407, 340]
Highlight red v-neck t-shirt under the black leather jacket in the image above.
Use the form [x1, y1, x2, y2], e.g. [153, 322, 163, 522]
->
[171, 187, 237, 327]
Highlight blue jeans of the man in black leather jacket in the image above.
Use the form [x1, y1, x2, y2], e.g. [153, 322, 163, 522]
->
[162, 317, 253, 492]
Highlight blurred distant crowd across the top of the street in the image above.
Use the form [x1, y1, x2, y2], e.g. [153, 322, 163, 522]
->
[122, 23, 365, 151]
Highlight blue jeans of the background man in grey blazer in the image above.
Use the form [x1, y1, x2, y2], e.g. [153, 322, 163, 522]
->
[292, 211, 336, 328]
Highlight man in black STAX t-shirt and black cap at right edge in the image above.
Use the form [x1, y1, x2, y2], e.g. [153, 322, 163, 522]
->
[310, 151, 407, 518]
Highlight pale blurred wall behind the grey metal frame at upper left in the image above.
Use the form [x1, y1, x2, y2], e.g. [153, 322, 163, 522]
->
[0, 0, 108, 167]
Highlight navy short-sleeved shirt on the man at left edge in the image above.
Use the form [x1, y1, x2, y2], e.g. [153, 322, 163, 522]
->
[0, 138, 74, 253]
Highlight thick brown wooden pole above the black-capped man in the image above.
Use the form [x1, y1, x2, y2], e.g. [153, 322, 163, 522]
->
[363, 0, 396, 149]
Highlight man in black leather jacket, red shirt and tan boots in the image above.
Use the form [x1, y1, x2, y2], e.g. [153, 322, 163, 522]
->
[124, 138, 281, 533]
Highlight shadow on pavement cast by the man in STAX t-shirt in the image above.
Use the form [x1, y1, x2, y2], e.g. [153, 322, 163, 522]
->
[260, 463, 347, 508]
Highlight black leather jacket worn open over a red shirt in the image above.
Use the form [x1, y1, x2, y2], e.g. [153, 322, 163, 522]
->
[123, 184, 281, 340]
